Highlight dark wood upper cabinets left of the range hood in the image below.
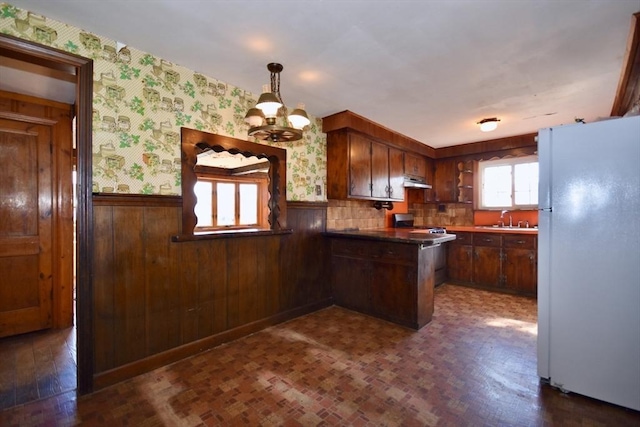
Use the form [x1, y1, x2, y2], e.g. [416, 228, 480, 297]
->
[327, 131, 404, 201]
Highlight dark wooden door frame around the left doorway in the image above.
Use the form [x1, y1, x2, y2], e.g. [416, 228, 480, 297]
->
[0, 34, 94, 395]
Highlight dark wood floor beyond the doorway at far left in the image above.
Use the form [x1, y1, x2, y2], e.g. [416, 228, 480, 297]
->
[0, 327, 76, 410]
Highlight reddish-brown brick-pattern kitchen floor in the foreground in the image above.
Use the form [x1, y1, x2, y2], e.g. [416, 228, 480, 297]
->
[0, 284, 640, 426]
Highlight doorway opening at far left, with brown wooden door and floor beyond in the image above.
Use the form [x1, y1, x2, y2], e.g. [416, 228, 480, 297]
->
[0, 93, 76, 409]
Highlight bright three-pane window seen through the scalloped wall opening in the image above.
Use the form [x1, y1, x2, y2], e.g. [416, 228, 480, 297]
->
[194, 175, 267, 231]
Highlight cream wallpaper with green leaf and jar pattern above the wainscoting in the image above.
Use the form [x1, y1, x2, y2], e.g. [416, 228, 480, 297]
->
[0, 3, 327, 201]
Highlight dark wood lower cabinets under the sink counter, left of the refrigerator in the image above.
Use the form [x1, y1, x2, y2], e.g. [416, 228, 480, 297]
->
[447, 232, 538, 296]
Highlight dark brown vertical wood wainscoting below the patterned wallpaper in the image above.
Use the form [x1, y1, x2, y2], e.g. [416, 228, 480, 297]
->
[93, 194, 333, 389]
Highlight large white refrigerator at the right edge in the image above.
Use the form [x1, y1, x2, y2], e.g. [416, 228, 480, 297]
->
[538, 116, 640, 410]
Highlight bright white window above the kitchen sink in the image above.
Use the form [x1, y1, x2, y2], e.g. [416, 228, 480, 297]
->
[478, 156, 538, 209]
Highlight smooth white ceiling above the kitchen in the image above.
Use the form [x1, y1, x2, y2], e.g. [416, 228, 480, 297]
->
[5, 0, 640, 148]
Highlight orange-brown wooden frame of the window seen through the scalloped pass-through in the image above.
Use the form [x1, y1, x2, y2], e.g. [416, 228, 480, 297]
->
[194, 172, 269, 232]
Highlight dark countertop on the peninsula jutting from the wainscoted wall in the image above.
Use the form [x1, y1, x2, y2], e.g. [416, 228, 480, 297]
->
[324, 228, 456, 246]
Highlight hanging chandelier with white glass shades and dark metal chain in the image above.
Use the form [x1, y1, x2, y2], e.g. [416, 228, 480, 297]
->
[244, 62, 311, 142]
